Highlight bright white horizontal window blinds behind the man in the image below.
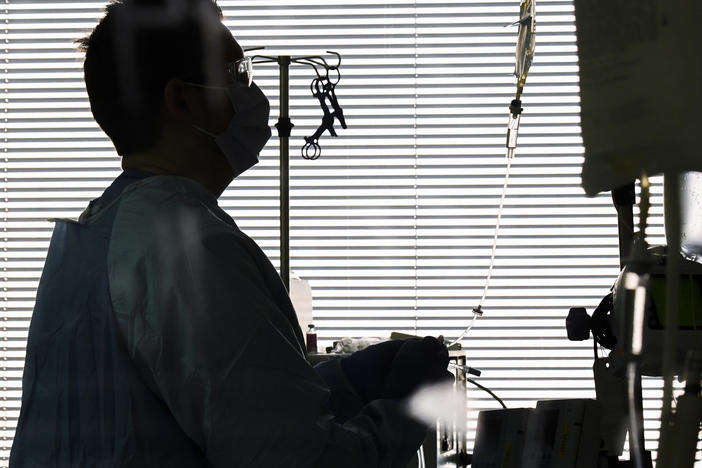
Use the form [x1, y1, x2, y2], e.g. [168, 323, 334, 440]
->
[0, 0, 692, 466]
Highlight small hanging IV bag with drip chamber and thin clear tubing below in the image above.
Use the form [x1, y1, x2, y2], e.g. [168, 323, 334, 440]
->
[448, 0, 536, 347]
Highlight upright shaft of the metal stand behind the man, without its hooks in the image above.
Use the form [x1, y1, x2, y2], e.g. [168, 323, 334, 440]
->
[276, 55, 292, 291]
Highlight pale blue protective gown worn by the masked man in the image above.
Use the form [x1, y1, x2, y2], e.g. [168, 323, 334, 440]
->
[10, 174, 426, 468]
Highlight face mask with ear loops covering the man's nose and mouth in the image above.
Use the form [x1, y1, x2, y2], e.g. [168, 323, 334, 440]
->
[191, 83, 271, 177]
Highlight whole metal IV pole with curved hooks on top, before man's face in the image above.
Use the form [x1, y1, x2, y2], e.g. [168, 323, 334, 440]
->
[251, 49, 341, 291]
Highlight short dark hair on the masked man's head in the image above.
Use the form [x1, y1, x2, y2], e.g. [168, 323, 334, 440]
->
[77, 0, 222, 156]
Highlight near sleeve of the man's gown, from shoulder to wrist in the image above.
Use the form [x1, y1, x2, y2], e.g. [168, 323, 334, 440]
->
[108, 178, 426, 468]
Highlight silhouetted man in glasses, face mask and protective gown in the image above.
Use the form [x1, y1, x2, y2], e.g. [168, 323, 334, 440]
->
[10, 0, 450, 468]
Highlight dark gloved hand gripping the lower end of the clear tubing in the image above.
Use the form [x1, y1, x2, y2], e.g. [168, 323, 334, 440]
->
[382, 336, 454, 400]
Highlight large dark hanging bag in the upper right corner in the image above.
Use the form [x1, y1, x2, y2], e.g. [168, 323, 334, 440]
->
[575, 0, 702, 195]
